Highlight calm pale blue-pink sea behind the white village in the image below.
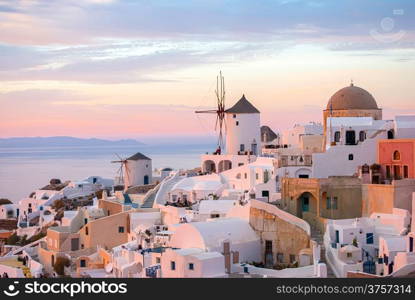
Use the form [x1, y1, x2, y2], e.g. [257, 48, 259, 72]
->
[0, 144, 213, 202]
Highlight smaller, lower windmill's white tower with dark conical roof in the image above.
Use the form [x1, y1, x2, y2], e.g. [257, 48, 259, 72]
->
[123, 152, 153, 189]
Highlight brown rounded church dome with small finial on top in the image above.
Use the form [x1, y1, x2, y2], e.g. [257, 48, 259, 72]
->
[327, 83, 378, 110]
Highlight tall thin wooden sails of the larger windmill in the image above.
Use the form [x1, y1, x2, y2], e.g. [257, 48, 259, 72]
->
[195, 72, 226, 149]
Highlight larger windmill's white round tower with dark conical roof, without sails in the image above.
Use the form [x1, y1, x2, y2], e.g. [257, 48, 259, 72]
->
[225, 95, 261, 156]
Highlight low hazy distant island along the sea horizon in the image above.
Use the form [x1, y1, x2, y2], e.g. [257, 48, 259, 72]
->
[0, 136, 145, 147]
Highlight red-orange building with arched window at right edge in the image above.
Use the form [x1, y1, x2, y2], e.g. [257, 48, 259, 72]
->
[378, 139, 415, 179]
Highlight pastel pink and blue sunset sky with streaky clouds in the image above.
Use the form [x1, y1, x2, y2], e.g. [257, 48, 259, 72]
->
[0, 0, 415, 139]
